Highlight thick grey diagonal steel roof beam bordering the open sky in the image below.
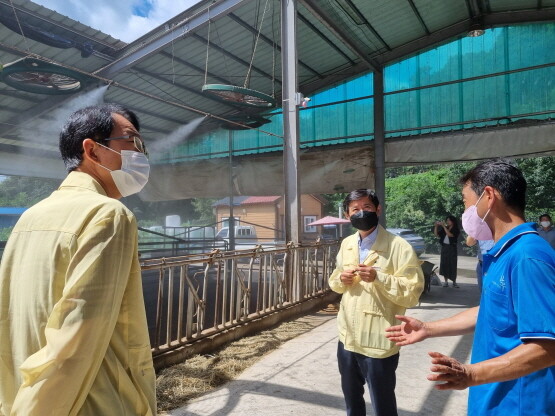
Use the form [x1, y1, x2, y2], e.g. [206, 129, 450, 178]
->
[96, 0, 251, 78]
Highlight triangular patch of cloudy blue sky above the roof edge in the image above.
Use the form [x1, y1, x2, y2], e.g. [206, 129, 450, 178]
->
[33, 0, 199, 43]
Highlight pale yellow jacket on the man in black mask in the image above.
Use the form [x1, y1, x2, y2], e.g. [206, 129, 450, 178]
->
[329, 225, 424, 358]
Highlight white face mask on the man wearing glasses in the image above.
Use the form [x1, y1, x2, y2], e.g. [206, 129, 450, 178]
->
[98, 143, 150, 197]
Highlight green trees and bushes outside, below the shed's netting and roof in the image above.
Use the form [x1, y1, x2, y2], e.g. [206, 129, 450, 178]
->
[0, 157, 555, 251]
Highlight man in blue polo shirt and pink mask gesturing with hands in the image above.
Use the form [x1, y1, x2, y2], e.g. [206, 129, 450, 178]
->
[386, 160, 555, 416]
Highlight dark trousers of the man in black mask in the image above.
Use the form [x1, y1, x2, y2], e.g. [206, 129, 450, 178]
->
[337, 342, 399, 416]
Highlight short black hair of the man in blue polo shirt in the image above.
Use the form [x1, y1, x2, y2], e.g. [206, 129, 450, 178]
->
[460, 159, 527, 215]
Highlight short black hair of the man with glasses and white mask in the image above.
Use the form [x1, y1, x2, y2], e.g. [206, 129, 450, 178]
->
[59, 103, 140, 172]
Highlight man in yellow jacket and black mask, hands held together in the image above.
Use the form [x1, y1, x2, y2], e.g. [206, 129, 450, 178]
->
[329, 189, 424, 416]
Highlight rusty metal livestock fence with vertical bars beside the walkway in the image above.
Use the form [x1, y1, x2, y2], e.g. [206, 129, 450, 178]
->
[141, 241, 339, 356]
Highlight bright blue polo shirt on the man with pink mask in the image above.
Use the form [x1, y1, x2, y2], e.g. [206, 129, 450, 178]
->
[468, 223, 555, 416]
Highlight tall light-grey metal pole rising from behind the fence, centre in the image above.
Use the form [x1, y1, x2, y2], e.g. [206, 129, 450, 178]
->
[281, 0, 301, 243]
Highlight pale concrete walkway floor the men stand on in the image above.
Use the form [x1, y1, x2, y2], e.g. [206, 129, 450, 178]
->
[169, 255, 479, 416]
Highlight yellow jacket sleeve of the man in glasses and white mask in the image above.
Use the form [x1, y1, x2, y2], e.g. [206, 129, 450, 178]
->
[11, 213, 137, 416]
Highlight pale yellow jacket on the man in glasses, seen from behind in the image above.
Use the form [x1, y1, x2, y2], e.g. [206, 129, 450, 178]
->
[0, 172, 156, 416]
